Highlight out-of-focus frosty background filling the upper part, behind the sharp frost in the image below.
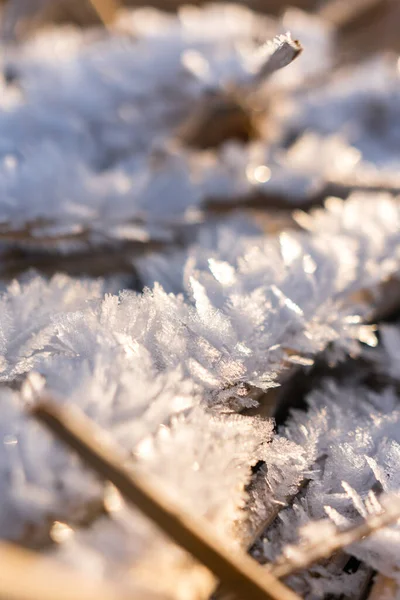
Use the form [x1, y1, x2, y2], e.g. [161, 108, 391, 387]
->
[0, 0, 400, 282]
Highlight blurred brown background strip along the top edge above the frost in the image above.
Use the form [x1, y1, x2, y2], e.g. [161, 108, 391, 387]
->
[0, 0, 400, 51]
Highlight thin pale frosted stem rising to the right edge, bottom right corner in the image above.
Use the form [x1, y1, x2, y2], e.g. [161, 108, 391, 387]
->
[267, 499, 400, 579]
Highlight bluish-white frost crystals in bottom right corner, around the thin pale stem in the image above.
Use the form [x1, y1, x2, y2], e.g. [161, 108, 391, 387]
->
[263, 380, 400, 598]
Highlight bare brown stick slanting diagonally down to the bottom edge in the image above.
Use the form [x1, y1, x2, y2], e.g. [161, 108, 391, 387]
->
[32, 400, 300, 600]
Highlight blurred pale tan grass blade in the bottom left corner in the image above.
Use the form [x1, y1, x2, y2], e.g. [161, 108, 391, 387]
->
[0, 542, 144, 600]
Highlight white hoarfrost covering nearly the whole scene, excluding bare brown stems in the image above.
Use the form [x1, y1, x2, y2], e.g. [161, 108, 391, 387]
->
[0, 3, 400, 600]
